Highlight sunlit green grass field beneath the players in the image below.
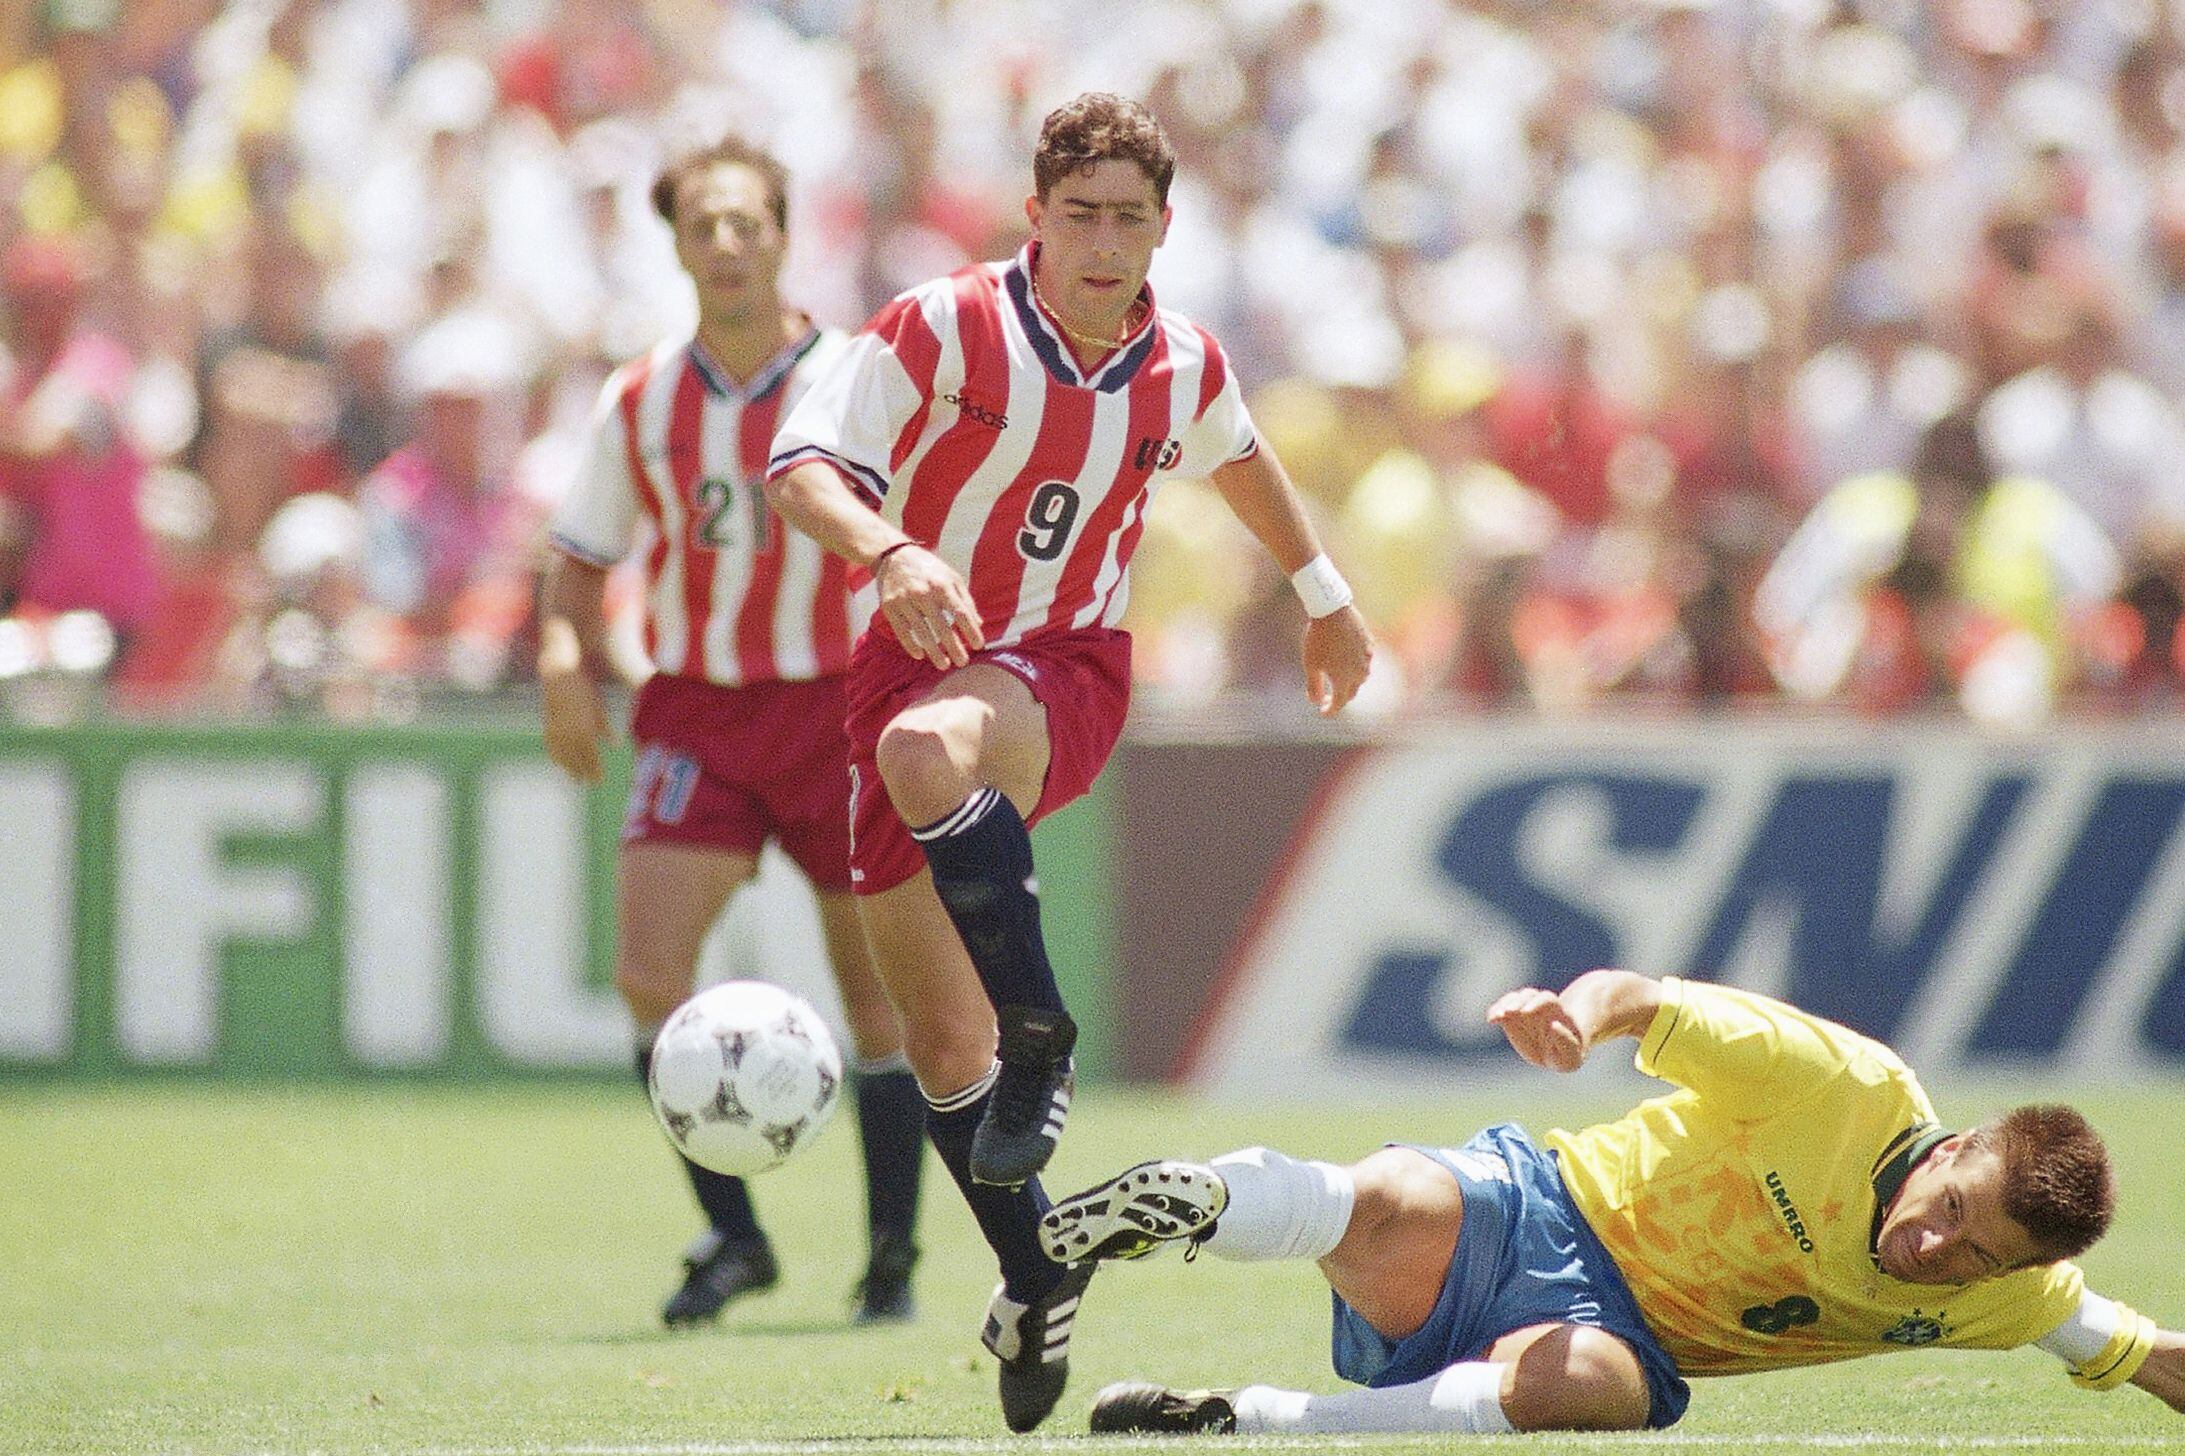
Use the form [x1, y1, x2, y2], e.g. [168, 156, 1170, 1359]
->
[12, 1082, 2185, 1456]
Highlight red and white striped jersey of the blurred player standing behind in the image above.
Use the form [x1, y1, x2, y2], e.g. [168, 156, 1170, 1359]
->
[551, 330, 870, 686]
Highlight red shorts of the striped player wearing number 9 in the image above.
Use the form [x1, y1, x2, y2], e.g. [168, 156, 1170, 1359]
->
[850, 623, 1130, 894]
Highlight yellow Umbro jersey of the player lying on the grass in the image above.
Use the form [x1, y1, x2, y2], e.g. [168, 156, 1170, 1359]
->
[1545, 977, 2084, 1375]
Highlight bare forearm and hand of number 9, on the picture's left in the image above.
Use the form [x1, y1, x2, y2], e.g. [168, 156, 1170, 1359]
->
[767, 461, 985, 671]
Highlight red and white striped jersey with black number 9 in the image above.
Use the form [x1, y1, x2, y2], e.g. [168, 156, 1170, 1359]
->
[767, 243, 1259, 647]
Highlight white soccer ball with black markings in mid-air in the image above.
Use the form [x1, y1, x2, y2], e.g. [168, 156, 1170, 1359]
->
[649, 982, 841, 1178]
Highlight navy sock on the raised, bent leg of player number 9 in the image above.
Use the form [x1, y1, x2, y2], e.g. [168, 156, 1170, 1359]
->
[911, 787, 1064, 1012]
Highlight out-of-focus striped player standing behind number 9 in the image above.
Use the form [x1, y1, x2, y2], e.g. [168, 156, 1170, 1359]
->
[540, 138, 924, 1325]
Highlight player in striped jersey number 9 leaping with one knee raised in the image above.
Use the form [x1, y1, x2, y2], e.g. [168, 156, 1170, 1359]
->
[767, 94, 1372, 1430]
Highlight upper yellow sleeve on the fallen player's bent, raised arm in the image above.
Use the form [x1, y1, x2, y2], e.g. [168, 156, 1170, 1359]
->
[1632, 975, 1905, 1119]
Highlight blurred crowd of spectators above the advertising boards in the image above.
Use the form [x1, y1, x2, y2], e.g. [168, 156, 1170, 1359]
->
[0, 0, 2185, 726]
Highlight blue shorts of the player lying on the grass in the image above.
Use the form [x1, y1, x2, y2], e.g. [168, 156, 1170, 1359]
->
[1333, 1122, 1691, 1428]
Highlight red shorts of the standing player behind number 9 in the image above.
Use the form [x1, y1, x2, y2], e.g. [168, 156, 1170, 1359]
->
[623, 673, 850, 894]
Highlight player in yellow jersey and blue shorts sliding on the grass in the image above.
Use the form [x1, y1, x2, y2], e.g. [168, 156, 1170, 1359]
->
[1044, 971, 2185, 1432]
